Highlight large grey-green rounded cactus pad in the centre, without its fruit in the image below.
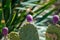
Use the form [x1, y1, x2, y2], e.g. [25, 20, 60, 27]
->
[19, 24, 39, 40]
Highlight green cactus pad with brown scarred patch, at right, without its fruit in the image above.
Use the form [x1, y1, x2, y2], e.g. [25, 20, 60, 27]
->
[46, 25, 60, 40]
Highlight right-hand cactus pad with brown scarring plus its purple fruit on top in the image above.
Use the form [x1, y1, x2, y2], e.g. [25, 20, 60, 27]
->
[46, 15, 60, 40]
